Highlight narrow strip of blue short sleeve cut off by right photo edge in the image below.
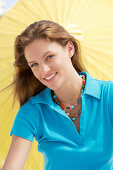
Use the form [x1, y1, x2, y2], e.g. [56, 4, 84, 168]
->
[108, 81, 113, 121]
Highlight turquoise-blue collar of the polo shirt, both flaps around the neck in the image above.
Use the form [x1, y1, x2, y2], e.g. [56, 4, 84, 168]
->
[30, 72, 101, 105]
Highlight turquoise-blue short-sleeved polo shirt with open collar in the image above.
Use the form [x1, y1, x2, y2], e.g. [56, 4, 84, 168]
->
[10, 72, 113, 170]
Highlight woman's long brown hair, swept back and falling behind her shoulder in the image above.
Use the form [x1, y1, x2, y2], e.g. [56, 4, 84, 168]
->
[8, 20, 86, 106]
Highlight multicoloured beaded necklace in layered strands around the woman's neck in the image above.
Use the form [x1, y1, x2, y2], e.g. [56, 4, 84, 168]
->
[52, 75, 86, 121]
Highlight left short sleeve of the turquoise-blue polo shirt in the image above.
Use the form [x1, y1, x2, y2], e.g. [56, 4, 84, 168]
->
[10, 102, 40, 142]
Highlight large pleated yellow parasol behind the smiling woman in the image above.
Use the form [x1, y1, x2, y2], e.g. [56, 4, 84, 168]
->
[0, 0, 113, 170]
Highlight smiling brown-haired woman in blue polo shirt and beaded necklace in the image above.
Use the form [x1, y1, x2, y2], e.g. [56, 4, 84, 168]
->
[3, 20, 113, 170]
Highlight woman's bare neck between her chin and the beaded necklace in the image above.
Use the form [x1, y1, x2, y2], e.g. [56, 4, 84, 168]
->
[54, 73, 82, 105]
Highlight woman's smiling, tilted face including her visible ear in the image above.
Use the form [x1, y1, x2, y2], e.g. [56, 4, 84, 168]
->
[24, 39, 74, 90]
